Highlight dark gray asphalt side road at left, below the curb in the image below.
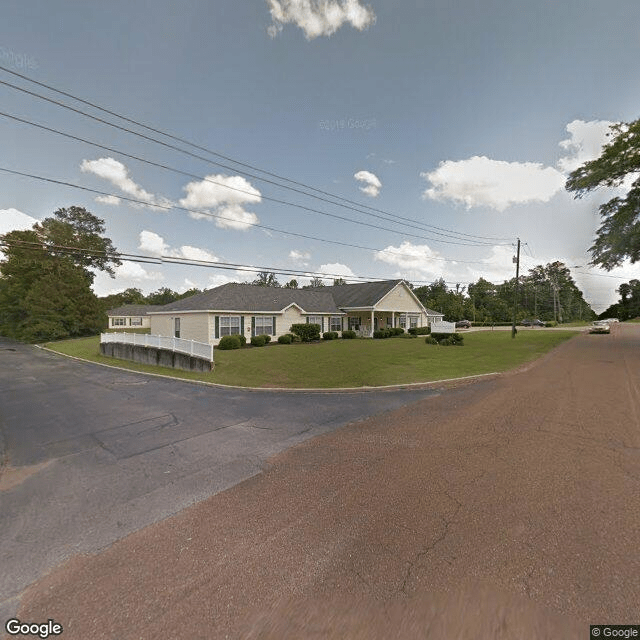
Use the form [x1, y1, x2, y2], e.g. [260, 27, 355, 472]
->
[0, 338, 437, 617]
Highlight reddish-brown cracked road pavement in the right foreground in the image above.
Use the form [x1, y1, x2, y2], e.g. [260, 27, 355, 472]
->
[5, 325, 640, 640]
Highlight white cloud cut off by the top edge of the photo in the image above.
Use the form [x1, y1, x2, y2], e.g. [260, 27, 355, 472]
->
[267, 0, 376, 40]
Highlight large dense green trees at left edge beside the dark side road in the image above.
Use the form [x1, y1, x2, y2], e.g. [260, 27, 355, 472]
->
[0, 207, 120, 341]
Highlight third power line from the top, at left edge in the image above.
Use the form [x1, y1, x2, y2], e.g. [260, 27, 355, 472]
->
[0, 109, 504, 246]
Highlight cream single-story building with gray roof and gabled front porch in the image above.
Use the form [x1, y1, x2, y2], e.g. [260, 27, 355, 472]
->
[149, 280, 442, 345]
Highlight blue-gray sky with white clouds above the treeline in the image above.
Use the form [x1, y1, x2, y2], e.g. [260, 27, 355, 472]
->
[0, 0, 640, 311]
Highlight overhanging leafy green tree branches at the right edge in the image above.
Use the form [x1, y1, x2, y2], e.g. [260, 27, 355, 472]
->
[566, 120, 640, 271]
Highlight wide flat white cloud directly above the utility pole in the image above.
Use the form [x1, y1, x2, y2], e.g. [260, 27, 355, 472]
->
[420, 156, 565, 211]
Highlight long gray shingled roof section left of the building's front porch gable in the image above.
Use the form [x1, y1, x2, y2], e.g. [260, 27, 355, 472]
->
[157, 283, 342, 315]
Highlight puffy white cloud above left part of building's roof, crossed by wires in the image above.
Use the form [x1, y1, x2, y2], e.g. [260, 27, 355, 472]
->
[180, 175, 262, 231]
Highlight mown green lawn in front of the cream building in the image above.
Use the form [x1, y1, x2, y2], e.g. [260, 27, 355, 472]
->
[46, 331, 576, 388]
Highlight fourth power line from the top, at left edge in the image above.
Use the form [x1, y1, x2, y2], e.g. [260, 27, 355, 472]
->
[0, 167, 510, 264]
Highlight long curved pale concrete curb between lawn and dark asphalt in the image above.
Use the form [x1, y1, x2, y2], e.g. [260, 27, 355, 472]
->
[34, 344, 506, 393]
